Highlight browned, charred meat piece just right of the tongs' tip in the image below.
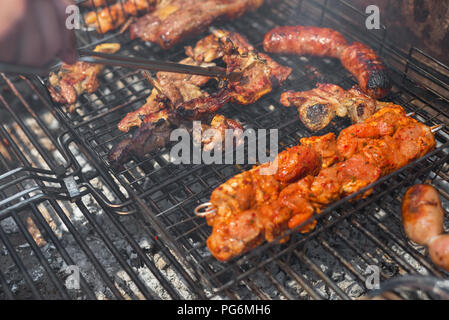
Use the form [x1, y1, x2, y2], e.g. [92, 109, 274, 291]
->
[213, 30, 292, 105]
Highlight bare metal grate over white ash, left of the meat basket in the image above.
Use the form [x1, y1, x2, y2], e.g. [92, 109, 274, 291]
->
[0, 75, 198, 299]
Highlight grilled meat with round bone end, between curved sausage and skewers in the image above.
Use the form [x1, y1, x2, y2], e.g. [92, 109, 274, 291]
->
[281, 84, 388, 131]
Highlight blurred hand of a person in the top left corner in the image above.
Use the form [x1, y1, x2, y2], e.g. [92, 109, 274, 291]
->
[0, 0, 77, 67]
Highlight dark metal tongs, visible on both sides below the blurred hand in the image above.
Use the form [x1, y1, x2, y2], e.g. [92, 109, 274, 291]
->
[0, 50, 242, 82]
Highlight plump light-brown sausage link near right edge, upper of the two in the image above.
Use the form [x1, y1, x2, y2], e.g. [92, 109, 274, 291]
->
[402, 184, 442, 246]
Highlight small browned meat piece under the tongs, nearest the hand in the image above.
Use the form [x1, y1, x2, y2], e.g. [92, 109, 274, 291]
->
[48, 43, 120, 105]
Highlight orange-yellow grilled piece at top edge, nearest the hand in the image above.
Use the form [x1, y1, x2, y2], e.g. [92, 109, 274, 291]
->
[84, 0, 160, 34]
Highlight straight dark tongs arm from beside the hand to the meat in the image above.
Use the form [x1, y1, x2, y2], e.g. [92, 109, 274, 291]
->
[79, 50, 241, 81]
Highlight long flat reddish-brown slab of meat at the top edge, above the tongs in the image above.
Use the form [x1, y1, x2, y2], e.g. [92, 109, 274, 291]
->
[130, 0, 264, 49]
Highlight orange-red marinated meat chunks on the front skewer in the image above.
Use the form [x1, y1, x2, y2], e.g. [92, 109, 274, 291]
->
[207, 106, 435, 261]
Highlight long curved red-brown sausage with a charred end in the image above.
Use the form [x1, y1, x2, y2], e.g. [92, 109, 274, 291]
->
[264, 26, 391, 99]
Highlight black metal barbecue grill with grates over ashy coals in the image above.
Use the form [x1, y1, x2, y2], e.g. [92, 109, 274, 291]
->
[0, 0, 449, 299]
